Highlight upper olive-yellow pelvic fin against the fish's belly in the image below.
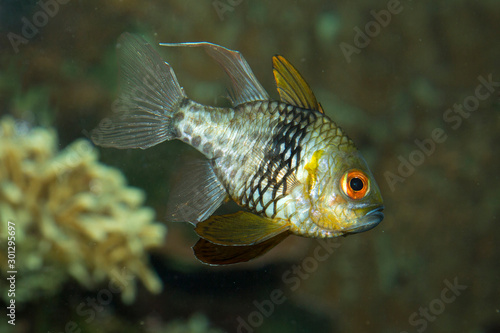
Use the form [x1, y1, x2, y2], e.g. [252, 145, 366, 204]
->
[195, 212, 290, 246]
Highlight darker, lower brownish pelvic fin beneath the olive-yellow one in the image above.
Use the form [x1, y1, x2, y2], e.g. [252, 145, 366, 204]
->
[193, 231, 290, 265]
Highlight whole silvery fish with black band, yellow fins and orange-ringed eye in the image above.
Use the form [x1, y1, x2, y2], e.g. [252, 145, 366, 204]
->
[91, 33, 384, 265]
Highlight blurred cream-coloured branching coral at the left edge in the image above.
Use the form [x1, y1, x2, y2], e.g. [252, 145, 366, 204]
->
[0, 117, 166, 302]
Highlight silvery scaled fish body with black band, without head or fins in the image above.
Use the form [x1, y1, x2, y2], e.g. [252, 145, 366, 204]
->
[174, 101, 352, 229]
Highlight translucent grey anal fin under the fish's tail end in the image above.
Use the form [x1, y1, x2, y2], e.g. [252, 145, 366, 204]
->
[167, 160, 227, 224]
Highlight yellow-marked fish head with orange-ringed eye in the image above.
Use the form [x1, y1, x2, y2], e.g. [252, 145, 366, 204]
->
[306, 147, 384, 237]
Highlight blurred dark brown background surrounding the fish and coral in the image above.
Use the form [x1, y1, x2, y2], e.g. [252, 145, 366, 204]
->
[0, 0, 500, 333]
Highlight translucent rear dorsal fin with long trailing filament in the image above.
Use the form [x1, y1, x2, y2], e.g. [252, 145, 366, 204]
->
[160, 42, 269, 106]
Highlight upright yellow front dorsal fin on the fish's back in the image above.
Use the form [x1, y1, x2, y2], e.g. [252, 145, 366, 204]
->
[273, 55, 324, 113]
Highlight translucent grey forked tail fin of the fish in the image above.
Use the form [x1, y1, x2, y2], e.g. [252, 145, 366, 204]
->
[92, 33, 187, 149]
